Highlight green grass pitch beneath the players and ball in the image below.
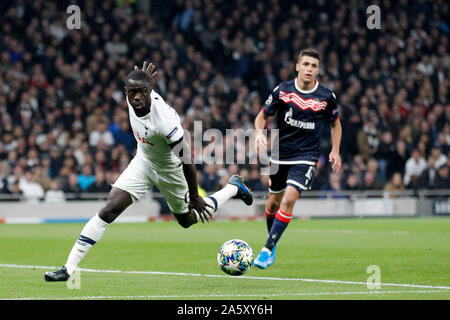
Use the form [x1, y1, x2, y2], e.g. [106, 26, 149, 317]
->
[0, 218, 450, 300]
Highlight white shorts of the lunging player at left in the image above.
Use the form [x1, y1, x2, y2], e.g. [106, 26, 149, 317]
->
[112, 156, 189, 214]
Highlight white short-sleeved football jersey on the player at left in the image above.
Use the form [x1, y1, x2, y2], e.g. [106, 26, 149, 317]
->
[127, 90, 184, 171]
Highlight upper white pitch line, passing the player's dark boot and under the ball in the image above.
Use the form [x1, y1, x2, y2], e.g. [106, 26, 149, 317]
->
[0, 264, 450, 290]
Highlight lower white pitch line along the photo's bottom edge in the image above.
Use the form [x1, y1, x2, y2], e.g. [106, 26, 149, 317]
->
[0, 290, 448, 300]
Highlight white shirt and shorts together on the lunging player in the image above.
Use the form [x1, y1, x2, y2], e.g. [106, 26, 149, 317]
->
[113, 90, 188, 214]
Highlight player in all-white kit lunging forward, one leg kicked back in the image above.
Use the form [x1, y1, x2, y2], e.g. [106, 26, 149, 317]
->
[44, 62, 253, 281]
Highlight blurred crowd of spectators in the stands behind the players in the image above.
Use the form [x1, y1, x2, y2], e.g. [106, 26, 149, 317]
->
[0, 0, 450, 202]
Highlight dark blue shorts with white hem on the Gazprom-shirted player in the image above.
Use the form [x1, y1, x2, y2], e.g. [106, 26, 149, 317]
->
[269, 163, 316, 193]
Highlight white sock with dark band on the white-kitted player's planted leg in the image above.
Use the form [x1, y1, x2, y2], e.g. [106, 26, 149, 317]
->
[65, 214, 109, 275]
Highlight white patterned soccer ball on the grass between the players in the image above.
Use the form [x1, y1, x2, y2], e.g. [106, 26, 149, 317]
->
[217, 239, 254, 276]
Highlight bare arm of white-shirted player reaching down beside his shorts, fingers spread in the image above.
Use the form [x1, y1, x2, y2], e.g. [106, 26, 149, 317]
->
[172, 139, 214, 223]
